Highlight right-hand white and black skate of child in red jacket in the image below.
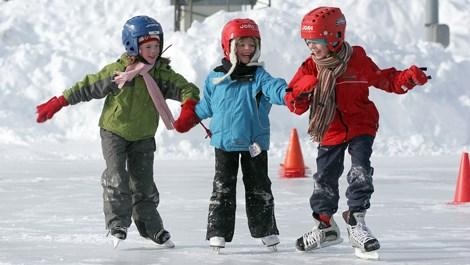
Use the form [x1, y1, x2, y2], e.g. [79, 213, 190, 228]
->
[343, 211, 380, 260]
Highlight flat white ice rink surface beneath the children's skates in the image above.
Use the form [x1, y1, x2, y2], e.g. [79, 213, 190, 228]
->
[0, 156, 470, 265]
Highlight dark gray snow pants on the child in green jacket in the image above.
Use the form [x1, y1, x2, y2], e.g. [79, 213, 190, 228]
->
[100, 129, 163, 237]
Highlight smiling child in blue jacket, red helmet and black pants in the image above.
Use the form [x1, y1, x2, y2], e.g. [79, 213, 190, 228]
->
[174, 19, 306, 251]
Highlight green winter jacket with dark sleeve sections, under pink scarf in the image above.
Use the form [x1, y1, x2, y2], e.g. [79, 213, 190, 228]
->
[63, 54, 199, 141]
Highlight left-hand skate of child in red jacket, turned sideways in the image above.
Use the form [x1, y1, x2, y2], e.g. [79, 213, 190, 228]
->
[295, 214, 343, 251]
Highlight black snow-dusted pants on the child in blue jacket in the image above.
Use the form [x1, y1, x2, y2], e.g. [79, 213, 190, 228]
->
[206, 149, 279, 242]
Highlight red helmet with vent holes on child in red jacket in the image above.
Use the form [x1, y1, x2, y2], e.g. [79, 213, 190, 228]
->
[300, 6, 346, 52]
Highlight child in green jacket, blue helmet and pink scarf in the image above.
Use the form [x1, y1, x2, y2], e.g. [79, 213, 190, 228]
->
[37, 16, 199, 247]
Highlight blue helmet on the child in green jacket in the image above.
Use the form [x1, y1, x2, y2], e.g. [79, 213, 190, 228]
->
[122, 16, 163, 56]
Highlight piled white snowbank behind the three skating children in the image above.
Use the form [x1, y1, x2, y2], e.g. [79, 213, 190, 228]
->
[0, 0, 470, 160]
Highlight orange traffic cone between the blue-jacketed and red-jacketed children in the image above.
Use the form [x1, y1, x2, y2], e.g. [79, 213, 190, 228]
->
[279, 128, 308, 178]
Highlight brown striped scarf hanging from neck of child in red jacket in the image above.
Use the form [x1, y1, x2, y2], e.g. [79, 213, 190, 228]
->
[308, 42, 352, 142]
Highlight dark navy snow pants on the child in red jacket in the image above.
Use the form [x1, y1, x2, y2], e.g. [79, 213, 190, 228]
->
[310, 135, 374, 216]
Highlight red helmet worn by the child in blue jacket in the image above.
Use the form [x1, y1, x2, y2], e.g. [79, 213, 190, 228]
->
[222, 18, 261, 60]
